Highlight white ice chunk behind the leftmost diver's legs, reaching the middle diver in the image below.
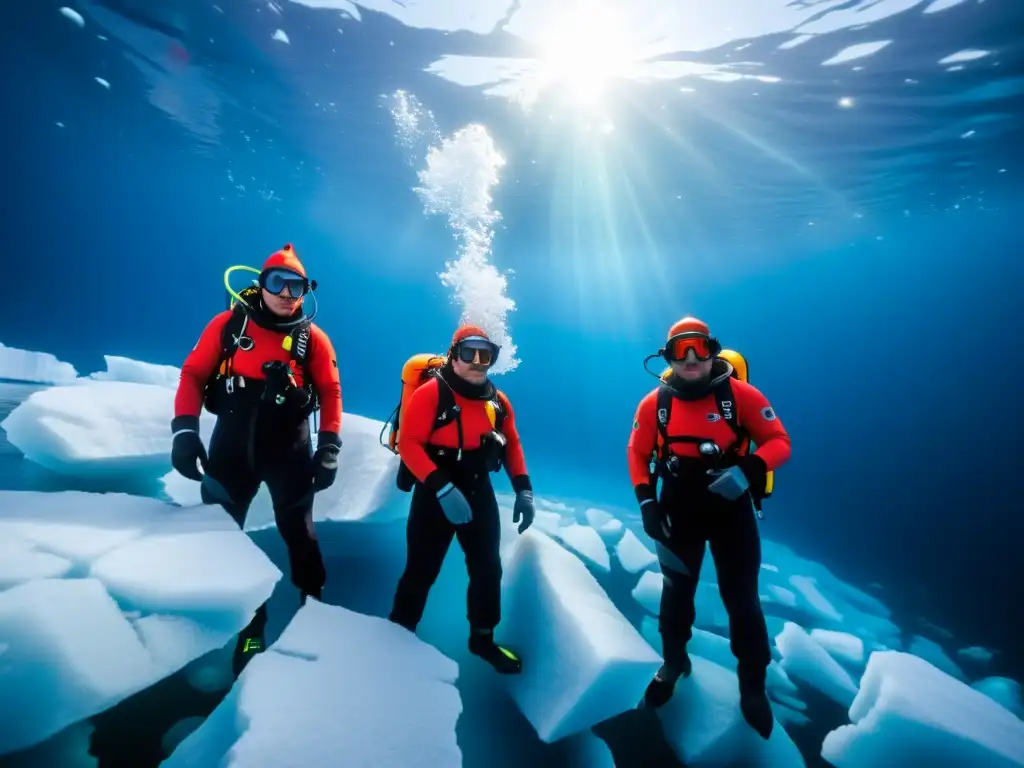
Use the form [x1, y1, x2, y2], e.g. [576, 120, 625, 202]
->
[163, 414, 409, 530]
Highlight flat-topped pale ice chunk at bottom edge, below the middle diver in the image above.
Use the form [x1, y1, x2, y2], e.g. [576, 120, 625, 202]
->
[163, 606, 462, 768]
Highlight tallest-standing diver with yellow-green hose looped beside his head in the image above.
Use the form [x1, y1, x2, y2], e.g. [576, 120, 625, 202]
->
[171, 244, 342, 675]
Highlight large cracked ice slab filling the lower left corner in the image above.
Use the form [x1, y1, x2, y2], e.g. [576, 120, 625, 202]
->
[0, 492, 281, 755]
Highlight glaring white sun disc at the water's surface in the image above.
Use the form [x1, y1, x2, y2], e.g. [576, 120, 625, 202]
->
[539, 3, 636, 106]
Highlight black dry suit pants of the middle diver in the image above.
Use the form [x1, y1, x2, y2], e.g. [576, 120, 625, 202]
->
[390, 472, 502, 632]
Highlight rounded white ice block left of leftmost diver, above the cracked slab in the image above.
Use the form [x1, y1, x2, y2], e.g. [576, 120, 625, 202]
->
[0, 381, 205, 478]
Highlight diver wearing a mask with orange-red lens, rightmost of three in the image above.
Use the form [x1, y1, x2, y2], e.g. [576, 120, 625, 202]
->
[627, 317, 791, 739]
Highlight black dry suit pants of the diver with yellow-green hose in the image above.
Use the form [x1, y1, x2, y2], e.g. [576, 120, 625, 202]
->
[203, 406, 327, 629]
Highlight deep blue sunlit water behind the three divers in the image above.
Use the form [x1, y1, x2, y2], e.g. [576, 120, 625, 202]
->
[0, 0, 1024, 765]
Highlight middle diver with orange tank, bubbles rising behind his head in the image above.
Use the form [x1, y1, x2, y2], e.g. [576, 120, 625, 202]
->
[388, 326, 535, 674]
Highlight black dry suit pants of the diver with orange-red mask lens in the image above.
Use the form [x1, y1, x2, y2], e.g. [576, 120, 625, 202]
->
[658, 478, 771, 690]
